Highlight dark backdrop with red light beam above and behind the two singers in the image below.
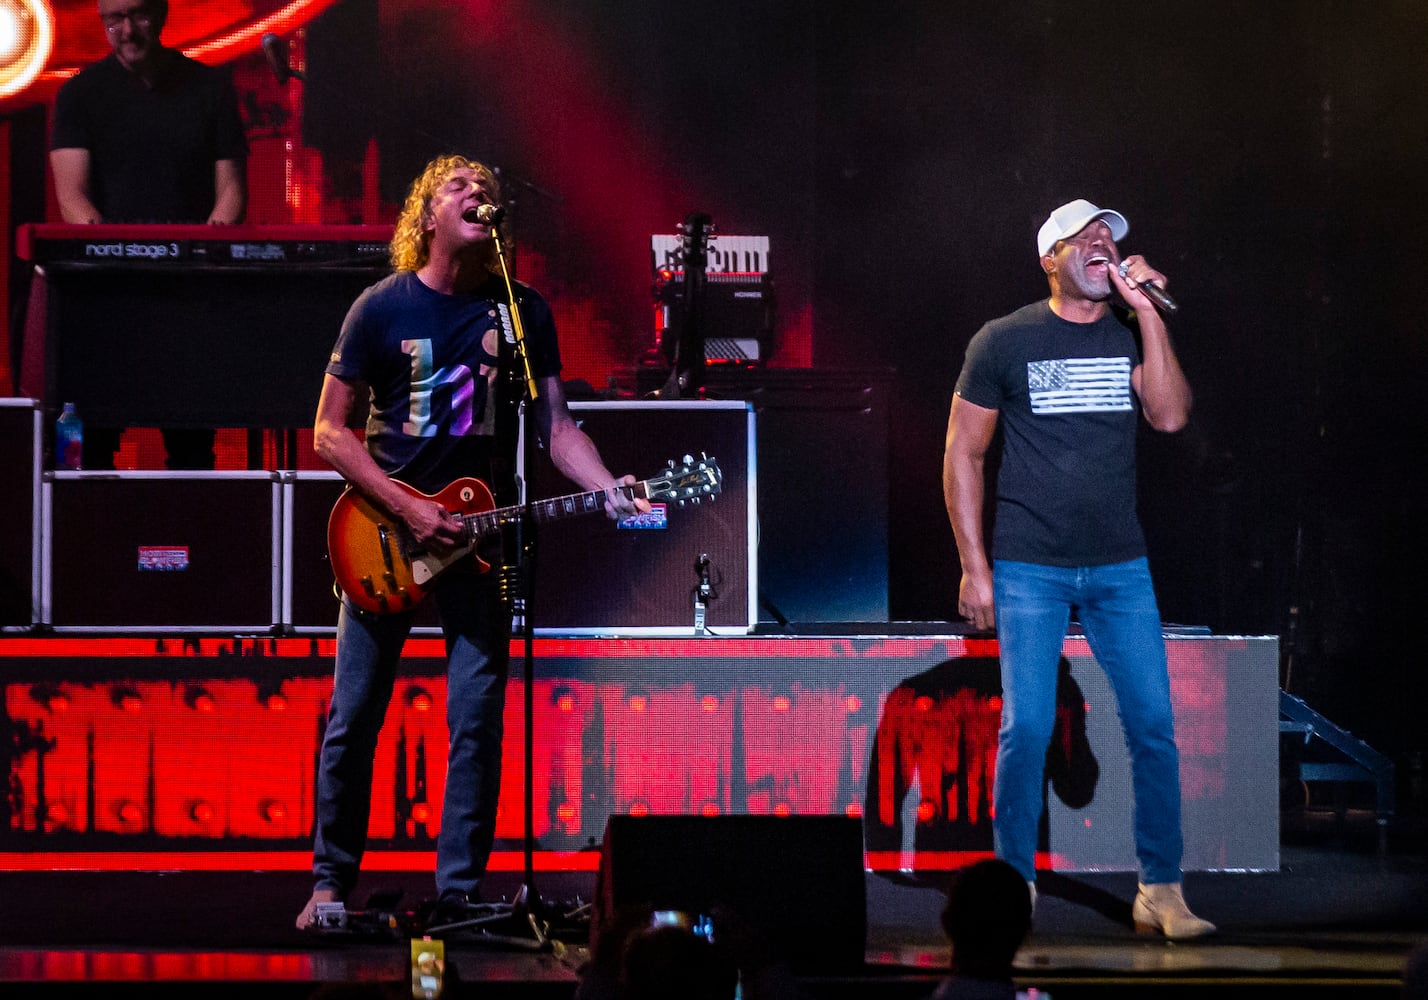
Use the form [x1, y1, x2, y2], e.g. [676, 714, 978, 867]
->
[11, 0, 1428, 770]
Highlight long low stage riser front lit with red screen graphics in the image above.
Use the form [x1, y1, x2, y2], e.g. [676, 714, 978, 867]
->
[0, 637, 1278, 871]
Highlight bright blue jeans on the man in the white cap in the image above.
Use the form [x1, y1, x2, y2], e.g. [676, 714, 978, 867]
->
[992, 559, 1182, 883]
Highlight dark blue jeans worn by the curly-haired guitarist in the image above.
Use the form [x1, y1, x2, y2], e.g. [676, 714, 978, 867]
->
[313, 566, 510, 896]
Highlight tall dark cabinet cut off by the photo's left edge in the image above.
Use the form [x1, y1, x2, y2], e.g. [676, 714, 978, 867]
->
[0, 399, 44, 627]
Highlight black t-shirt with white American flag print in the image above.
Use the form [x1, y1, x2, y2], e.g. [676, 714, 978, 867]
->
[957, 300, 1145, 566]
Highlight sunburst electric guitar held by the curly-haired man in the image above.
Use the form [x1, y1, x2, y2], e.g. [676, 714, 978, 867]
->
[327, 456, 724, 614]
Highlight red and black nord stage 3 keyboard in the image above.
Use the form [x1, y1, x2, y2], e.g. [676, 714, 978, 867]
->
[16, 223, 391, 267]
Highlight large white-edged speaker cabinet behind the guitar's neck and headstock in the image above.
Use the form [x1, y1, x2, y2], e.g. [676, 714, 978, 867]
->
[526, 400, 758, 636]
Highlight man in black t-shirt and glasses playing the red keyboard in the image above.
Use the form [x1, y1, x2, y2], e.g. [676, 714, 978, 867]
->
[50, 0, 248, 469]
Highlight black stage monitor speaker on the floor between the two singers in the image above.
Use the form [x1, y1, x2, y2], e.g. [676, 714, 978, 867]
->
[593, 816, 868, 973]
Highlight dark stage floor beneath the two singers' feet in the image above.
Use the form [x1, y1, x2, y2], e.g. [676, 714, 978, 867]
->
[0, 844, 1428, 999]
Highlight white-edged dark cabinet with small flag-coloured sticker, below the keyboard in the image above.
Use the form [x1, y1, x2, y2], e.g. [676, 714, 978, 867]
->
[40, 471, 281, 633]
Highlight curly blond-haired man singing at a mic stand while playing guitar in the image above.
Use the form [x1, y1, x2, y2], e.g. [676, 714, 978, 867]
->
[297, 156, 650, 929]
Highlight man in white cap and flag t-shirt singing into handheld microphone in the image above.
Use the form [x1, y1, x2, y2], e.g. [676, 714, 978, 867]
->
[942, 200, 1215, 939]
